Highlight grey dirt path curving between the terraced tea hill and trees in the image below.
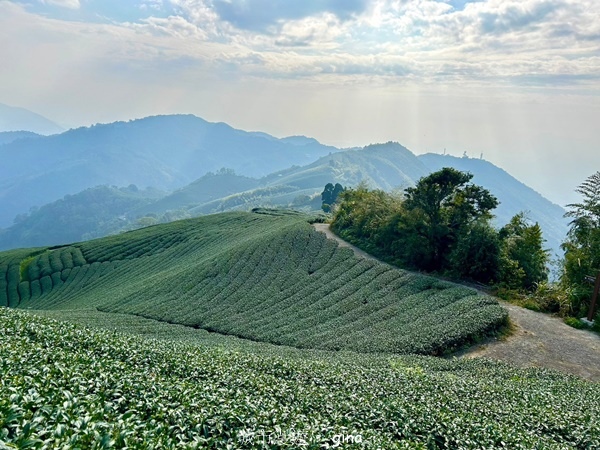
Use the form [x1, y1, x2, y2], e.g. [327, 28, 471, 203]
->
[314, 223, 600, 381]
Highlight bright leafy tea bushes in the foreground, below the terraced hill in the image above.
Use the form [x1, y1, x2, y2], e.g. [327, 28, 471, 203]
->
[0, 308, 600, 449]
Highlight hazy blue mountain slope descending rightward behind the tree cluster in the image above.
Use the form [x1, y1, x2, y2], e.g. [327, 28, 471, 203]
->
[418, 153, 568, 255]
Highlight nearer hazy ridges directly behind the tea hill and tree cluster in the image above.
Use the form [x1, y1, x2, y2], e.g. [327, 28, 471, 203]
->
[0, 132, 567, 253]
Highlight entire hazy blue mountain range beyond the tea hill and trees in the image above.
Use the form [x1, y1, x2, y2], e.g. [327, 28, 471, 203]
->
[0, 115, 567, 252]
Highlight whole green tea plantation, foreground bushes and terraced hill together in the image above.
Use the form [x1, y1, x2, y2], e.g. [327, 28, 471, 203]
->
[0, 211, 600, 450]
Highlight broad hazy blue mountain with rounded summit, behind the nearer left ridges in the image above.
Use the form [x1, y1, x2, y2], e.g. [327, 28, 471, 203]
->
[0, 115, 337, 227]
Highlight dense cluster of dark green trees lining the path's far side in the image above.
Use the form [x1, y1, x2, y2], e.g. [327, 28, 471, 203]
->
[331, 168, 549, 289]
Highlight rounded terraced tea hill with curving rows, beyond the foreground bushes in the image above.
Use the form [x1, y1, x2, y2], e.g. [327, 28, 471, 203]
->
[0, 213, 506, 354]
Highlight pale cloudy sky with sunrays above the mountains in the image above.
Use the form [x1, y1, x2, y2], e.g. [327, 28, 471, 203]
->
[0, 0, 600, 205]
